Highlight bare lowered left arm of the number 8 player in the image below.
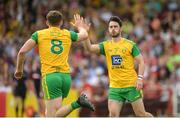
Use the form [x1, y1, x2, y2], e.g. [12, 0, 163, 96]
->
[14, 39, 36, 79]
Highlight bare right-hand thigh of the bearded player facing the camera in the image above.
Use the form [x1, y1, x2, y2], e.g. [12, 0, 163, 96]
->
[131, 98, 146, 116]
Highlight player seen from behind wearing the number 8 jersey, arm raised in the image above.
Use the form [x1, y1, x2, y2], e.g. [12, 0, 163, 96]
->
[14, 11, 94, 117]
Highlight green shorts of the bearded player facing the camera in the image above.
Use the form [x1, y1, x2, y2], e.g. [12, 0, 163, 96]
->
[108, 87, 142, 102]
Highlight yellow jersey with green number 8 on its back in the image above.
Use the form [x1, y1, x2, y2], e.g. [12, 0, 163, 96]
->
[31, 27, 78, 76]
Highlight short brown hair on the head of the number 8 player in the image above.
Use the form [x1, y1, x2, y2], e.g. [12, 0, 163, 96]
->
[46, 10, 63, 26]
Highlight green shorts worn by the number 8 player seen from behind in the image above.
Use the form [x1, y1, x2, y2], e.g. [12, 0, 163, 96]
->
[42, 72, 71, 99]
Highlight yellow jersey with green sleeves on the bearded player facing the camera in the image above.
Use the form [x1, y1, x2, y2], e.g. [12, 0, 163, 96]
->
[99, 38, 140, 88]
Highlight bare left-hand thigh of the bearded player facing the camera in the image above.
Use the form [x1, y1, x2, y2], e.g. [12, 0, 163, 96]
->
[108, 100, 123, 117]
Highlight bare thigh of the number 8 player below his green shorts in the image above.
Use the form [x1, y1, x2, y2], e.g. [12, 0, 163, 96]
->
[45, 97, 62, 117]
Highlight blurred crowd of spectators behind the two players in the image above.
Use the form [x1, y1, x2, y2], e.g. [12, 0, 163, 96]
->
[0, 0, 180, 117]
